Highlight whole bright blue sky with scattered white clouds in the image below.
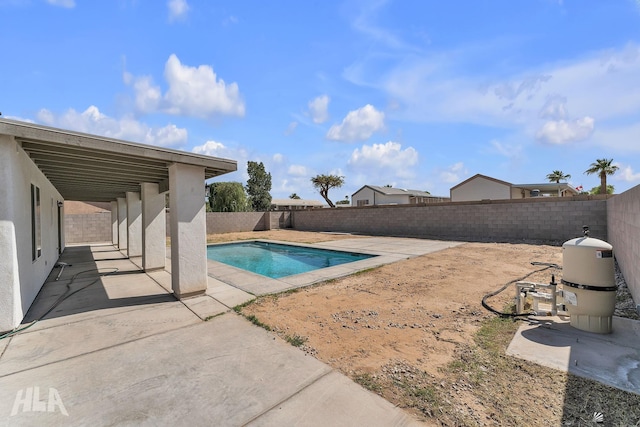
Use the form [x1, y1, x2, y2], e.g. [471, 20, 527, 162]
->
[0, 0, 640, 201]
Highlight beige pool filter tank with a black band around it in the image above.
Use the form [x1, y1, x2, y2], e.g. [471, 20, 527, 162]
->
[562, 226, 616, 334]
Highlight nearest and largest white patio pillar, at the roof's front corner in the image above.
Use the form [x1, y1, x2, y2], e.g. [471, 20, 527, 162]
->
[169, 163, 207, 298]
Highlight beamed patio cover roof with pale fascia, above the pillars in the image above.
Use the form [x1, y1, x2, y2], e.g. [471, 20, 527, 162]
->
[0, 119, 237, 202]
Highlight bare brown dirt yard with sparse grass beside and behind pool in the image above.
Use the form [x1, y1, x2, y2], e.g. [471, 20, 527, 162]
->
[210, 230, 640, 426]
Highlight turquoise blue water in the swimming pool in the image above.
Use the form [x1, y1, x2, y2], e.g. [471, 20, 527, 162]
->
[207, 242, 375, 279]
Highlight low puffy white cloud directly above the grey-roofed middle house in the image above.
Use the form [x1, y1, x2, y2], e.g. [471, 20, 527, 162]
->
[347, 141, 418, 180]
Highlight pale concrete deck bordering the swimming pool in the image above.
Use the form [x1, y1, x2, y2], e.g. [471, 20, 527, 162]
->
[207, 237, 462, 296]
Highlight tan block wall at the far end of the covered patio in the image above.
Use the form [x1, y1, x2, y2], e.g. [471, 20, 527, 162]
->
[64, 212, 112, 244]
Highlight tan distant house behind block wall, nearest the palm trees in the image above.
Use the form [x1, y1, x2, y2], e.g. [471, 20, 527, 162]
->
[449, 174, 579, 202]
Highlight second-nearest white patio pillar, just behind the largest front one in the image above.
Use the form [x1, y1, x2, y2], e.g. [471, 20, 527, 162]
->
[141, 182, 167, 271]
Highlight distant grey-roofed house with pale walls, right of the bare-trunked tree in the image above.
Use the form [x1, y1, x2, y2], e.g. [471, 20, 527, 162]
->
[351, 185, 449, 206]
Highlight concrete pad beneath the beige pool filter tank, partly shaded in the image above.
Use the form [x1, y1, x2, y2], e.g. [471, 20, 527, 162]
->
[507, 316, 640, 394]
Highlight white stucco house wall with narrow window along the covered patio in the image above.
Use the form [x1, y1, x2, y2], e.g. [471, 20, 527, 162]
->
[0, 135, 65, 331]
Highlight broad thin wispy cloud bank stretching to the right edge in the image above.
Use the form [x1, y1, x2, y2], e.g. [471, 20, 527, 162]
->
[344, 34, 640, 152]
